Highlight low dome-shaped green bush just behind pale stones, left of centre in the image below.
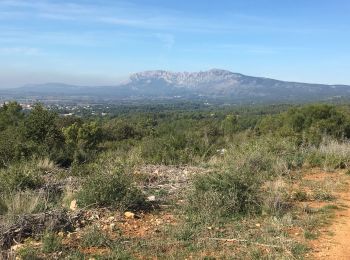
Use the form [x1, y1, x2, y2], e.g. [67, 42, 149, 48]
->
[77, 171, 147, 210]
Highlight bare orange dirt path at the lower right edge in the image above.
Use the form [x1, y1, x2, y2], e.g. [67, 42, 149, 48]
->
[312, 174, 350, 260]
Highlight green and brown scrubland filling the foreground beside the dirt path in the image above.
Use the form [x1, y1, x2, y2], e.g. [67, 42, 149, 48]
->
[0, 103, 350, 259]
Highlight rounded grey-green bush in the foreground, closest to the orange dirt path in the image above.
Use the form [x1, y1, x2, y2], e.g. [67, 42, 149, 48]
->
[188, 172, 262, 221]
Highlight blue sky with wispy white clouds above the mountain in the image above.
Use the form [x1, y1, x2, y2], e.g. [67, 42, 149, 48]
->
[0, 0, 350, 88]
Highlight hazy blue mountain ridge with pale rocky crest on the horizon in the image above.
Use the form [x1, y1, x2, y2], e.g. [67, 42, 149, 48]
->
[0, 69, 350, 102]
